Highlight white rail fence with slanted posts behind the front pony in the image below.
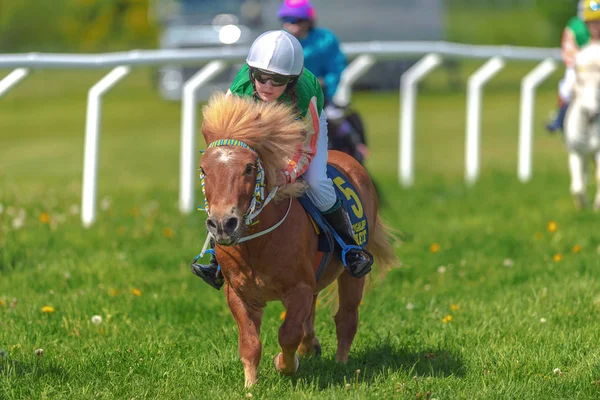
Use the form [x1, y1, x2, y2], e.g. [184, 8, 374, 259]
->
[0, 42, 560, 227]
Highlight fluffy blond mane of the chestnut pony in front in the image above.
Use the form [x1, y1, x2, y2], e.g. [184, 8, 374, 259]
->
[202, 92, 307, 199]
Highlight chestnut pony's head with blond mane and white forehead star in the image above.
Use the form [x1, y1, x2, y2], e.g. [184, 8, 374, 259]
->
[200, 93, 306, 245]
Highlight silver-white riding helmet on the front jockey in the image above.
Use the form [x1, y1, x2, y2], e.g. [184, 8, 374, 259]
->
[246, 30, 304, 76]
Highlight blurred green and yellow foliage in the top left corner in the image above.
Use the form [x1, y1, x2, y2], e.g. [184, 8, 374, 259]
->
[0, 0, 157, 52]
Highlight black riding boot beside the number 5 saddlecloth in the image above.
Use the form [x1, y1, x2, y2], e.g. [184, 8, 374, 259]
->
[323, 199, 373, 278]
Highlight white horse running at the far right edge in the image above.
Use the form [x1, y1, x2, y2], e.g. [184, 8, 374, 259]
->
[565, 41, 600, 211]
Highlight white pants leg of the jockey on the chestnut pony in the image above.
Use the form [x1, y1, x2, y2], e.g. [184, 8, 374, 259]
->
[302, 111, 337, 212]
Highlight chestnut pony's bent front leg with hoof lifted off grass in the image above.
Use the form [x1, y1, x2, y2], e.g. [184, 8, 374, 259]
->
[273, 285, 314, 375]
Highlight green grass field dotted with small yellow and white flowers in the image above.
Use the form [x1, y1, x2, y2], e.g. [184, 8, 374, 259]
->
[0, 64, 600, 400]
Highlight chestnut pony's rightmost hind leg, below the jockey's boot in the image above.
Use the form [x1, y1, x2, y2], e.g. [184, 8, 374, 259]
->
[335, 271, 365, 363]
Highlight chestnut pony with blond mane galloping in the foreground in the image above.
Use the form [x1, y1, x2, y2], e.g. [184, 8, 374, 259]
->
[201, 93, 397, 387]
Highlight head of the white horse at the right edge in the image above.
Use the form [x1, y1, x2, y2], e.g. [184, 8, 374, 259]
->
[575, 41, 600, 119]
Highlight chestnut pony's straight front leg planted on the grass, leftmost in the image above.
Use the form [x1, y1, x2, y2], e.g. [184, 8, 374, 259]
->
[225, 285, 263, 387]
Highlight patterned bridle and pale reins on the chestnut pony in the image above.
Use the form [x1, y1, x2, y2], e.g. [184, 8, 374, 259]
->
[198, 139, 292, 247]
